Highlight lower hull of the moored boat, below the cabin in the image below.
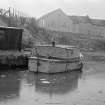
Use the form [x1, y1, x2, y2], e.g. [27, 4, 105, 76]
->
[28, 57, 82, 73]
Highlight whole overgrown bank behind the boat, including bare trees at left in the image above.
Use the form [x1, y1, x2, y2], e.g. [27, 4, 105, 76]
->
[0, 8, 105, 52]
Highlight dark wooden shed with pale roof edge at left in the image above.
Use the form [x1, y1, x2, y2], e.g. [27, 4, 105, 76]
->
[0, 26, 23, 51]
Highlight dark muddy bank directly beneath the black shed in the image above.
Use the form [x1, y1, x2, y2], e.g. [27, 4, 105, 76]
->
[0, 50, 28, 69]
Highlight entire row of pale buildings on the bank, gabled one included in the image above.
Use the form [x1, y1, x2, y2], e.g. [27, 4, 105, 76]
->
[37, 9, 105, 36]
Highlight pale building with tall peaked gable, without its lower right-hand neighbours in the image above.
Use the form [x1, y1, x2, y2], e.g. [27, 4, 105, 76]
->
[38, 9, 73, 32]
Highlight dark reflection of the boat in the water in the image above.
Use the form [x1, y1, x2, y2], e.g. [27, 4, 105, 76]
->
[27, 71, 81, 95]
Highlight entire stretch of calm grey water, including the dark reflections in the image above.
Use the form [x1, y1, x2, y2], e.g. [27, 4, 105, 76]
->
[0, 62, 105, 105]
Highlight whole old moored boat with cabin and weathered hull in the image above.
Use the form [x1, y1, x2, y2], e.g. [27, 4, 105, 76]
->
[28, 44, 83, 73]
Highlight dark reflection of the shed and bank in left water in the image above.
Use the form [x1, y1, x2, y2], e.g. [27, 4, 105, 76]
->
[0, 70, 20, 100]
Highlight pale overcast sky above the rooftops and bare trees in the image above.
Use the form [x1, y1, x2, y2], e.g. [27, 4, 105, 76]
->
[0, 0, 105, 19]
